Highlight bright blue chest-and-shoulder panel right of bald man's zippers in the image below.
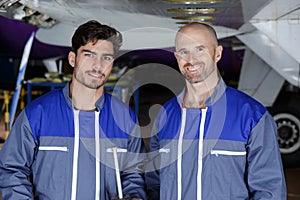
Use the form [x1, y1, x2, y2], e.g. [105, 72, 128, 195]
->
[206, 87, 266, 142]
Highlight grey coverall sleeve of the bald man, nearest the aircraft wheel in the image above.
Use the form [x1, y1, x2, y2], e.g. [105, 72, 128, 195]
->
[247, 112, 286, 200]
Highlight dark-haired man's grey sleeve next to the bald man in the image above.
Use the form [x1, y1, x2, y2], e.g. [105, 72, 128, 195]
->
[121, 126, 146, 200]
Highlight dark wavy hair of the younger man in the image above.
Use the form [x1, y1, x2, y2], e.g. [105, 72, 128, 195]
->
[72, 20, 123, 54]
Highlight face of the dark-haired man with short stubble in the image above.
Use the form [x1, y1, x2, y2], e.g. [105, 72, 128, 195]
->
[69, 40, 114, 89]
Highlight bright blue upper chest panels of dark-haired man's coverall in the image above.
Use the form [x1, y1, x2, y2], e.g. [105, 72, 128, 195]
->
[25, 89, 136, 140]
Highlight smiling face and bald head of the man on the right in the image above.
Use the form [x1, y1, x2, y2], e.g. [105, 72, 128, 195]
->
[174, 27, 222, 84]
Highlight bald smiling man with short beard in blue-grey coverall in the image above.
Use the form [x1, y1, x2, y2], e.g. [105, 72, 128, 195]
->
[146, 22, 286, 200]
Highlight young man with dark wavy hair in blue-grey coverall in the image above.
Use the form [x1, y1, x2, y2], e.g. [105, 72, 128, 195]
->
[0, 21, 145, 200]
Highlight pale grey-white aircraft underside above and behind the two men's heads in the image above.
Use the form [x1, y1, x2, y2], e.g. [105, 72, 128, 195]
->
[2, 0, 300, 105]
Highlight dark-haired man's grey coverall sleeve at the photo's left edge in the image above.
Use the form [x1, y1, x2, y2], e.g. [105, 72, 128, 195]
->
[0, 110, 36, 200]
